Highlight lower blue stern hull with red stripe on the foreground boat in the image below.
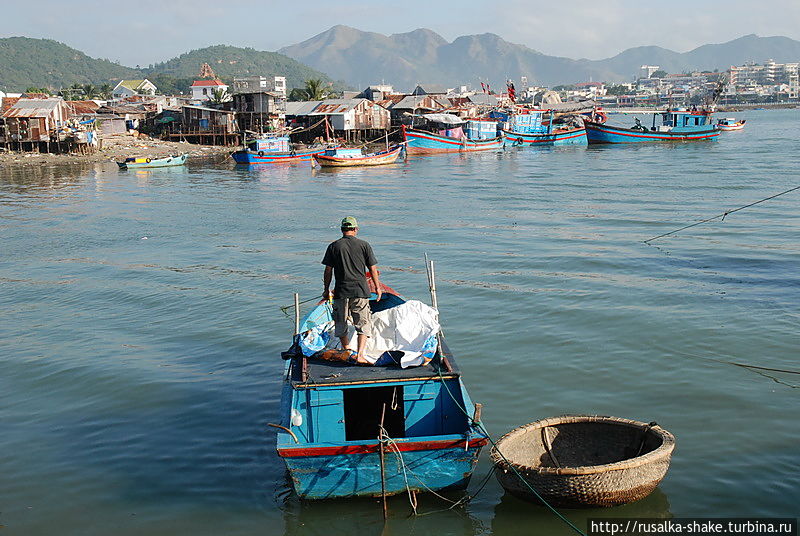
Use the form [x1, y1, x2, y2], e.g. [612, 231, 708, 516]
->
[278, 437, 487, 499]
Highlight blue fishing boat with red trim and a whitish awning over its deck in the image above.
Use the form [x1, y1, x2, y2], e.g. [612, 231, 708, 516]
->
[403, 113, 503, 154]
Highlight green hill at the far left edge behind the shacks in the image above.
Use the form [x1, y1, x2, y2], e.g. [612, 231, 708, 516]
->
[0, 37, 138, 91]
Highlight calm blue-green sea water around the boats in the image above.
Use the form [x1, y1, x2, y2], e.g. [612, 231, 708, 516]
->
[0, 110, 800, 536]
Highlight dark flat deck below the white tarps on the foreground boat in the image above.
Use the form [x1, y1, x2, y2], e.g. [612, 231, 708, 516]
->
[290, 341, 461, 387]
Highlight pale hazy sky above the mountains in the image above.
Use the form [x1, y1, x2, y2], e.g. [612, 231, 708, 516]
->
[0, 0, 800, 66]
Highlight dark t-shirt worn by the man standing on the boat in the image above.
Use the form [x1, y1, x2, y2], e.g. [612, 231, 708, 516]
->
[322, 236, 378, 299]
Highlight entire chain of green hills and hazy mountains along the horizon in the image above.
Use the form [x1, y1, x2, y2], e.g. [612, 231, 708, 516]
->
[0, 30, 800, 91]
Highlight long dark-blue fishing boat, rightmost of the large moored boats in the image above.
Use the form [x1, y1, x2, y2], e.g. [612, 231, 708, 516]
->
[585, 109, 720, 143]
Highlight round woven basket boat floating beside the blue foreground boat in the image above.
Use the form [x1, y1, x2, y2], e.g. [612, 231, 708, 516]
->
[491, 415, 675, 508]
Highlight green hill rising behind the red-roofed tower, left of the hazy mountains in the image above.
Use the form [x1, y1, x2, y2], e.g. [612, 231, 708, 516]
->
[143, 45, 344, 88]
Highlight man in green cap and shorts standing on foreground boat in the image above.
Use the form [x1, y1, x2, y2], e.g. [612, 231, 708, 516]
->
[322, 216, 381, 363]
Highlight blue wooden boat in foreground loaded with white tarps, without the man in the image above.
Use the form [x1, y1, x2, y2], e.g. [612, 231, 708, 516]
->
[271, 278, 488, 499]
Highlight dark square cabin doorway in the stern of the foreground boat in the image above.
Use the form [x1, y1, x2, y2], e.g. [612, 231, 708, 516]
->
[343, 386, 406, 441]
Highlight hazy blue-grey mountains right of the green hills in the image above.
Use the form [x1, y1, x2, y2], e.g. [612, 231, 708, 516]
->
[278, 25, 800, 89]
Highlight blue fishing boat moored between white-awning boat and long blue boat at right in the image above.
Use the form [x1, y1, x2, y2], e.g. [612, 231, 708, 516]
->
[502, 110, 588, 147]
